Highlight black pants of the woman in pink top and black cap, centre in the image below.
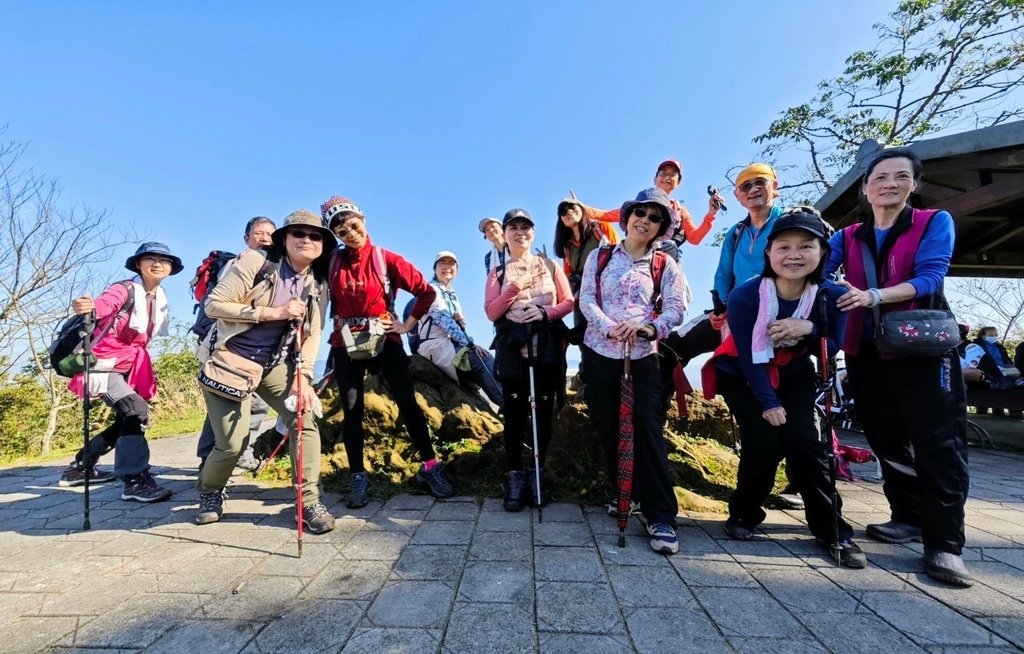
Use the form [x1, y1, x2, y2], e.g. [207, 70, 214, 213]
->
[502, 358, 565, 472]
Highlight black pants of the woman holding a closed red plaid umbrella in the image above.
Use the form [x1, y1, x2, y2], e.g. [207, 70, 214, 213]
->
[584, 351, 679, 527]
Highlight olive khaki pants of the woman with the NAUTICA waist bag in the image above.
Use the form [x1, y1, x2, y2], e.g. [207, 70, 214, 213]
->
[196, 361, 321, 507]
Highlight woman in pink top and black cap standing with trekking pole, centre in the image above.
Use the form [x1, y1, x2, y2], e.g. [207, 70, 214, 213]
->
[483, 209, 572, 511]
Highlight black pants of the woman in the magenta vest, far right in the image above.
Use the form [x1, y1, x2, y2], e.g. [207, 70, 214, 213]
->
[846, 344, 970, 554]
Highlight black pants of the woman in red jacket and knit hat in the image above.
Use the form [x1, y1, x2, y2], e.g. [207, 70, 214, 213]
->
[331, 337, 434, 473]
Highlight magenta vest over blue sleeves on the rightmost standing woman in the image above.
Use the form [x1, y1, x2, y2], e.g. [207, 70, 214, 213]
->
[843, 209, 938, 354]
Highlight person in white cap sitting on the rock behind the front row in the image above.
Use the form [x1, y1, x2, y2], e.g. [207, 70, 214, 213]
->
[417, 250, 505, 410]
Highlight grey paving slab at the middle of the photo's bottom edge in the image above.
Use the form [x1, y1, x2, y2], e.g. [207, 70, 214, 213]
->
[441, 602, 537, 654]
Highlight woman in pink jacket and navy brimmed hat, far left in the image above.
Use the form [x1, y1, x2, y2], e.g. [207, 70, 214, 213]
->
[59, 243, 183, 503]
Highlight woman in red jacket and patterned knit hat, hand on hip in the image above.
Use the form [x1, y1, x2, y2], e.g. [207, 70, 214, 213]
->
[321, 195, 455, 509]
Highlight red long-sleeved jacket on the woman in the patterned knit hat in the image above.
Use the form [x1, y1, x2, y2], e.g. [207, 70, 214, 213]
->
[330, 237, 436, 341]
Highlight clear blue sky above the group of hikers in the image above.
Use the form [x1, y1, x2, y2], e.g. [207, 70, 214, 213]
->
[0, 0, 895, 372]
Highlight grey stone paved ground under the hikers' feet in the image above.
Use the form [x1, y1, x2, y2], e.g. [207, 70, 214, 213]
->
[0, 437, 1024, 654]
